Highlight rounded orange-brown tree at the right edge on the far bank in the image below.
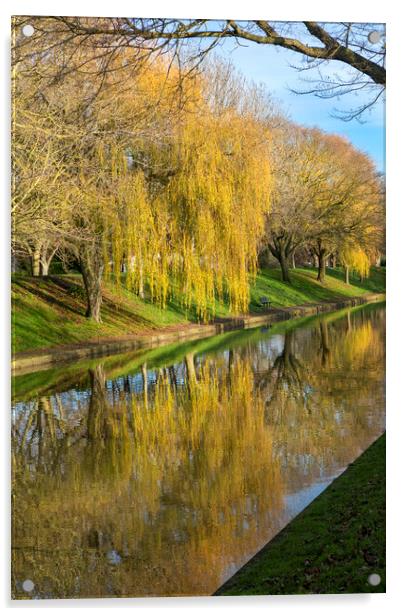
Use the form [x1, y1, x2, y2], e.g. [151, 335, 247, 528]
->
[309, 133, 384, 282]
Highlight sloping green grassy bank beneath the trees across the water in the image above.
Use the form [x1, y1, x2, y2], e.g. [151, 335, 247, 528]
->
[12, 268, 385, 352]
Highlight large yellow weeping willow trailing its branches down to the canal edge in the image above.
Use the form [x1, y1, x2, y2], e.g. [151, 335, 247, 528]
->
[75, 63, 271, 320]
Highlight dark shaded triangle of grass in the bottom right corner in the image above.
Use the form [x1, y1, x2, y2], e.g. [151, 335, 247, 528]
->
[216, 435, 385, 595]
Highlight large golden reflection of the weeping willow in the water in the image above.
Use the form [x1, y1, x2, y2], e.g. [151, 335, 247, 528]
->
[13, 361, 281, 596]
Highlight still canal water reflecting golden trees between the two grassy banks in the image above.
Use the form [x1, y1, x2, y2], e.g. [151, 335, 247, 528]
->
[12, 305, 385, 598]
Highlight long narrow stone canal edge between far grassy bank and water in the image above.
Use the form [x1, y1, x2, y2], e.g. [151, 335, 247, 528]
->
[11, 293, 385, 374]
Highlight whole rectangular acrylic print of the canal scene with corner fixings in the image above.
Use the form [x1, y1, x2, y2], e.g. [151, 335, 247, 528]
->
[11, 16, 386, 599]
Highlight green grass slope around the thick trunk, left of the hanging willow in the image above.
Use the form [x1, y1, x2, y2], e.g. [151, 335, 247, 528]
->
[12, 275, 187, 352]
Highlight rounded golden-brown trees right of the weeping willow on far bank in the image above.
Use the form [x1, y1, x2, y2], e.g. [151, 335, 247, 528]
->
[266, 123, 385, 282]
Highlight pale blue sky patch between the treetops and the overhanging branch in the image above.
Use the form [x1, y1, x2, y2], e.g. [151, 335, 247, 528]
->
[215, 35, 385, 171]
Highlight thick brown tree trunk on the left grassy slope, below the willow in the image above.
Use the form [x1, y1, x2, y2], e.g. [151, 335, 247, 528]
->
[80, 244, 104, 323]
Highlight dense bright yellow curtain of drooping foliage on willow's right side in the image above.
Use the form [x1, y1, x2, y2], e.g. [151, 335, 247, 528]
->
[166, 113, 271, 318]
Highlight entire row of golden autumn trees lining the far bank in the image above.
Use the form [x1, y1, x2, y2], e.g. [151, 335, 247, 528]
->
[12, 22, 383, 321]
